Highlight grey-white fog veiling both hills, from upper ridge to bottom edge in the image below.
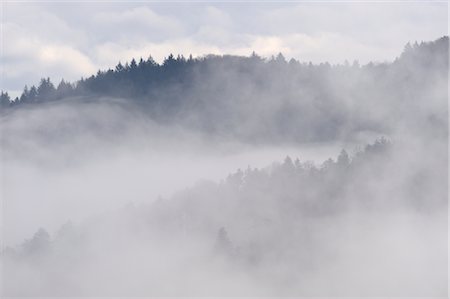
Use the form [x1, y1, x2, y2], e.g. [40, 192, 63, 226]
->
[0, 38, 448, 298]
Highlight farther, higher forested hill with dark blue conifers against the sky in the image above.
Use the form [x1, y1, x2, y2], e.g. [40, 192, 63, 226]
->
[0, 37, 448, 141]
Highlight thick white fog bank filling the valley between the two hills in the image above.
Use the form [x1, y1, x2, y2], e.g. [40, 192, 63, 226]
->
[2, 99, 356, 246]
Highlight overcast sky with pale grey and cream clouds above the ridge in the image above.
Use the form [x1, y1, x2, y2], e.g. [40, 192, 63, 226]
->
[0, 1, 448, 96]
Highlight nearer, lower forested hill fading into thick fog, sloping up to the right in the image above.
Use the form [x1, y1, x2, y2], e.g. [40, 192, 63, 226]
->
[1, 139, 447, 297]
